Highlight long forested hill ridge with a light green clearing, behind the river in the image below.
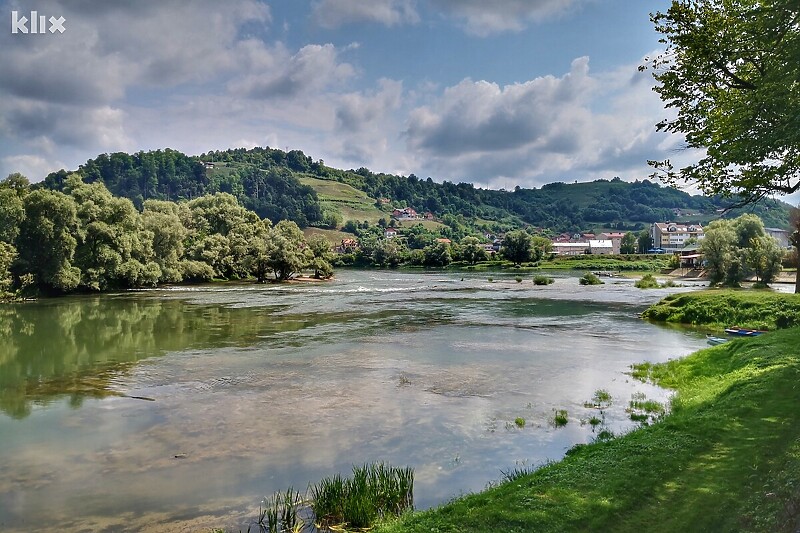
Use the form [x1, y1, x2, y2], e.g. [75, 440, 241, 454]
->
[45, 147, 788, 232]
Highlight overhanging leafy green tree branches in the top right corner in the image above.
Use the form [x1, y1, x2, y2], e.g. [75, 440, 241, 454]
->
[641, 0, 800, 201]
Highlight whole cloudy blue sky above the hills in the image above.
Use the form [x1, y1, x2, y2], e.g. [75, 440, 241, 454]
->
[0, 0, 708, 189]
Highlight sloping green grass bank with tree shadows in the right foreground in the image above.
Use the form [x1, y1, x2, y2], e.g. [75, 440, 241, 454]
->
[376, 328, 800, 533]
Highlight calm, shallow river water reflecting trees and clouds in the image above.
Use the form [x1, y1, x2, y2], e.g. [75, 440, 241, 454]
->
[0, 271, 705, 531]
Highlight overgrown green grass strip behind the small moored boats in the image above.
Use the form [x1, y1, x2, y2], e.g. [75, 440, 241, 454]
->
[642, 290, 800, 330]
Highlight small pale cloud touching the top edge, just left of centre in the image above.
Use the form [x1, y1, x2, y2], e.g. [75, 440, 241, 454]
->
[311, 0, 419, 28]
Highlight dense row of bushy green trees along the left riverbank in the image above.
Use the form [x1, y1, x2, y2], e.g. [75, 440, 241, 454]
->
[0, 174, 332, 295]
